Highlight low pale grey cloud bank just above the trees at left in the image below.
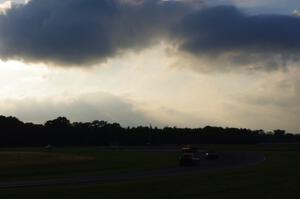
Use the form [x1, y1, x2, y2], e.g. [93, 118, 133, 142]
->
[0, 92, 158, 126]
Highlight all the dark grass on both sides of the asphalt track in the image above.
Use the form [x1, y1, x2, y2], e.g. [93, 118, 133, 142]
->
[0, 145, 300, 199]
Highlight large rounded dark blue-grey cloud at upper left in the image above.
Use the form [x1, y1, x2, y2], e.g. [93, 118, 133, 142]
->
[0, 0, 188, 65]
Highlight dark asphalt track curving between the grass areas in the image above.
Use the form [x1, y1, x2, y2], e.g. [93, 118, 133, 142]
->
[0, 150, 265, 189]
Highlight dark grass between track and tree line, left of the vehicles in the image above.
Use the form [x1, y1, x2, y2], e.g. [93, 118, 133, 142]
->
[0, 148, 178, 181]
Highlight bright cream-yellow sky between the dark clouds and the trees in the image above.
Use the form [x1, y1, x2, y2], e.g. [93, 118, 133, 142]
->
[0, 44, 300, 131]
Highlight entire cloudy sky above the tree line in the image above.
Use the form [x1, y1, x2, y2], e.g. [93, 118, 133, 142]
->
[0, 0, 300, 133]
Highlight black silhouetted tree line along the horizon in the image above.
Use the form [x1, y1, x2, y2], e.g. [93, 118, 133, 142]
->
[0, 116, 300, 147]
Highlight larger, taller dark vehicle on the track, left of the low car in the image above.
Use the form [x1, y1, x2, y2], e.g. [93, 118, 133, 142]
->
[179, 146, 200, 167]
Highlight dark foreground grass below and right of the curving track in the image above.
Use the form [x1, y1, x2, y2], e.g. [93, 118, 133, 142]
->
[0, 145, 300, 199]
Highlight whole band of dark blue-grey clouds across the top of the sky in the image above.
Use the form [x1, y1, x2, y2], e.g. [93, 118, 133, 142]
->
[0, 0, 300, 70]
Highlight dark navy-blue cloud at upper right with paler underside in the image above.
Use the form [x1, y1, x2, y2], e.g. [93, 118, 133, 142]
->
[174, 6, 300, 69]
